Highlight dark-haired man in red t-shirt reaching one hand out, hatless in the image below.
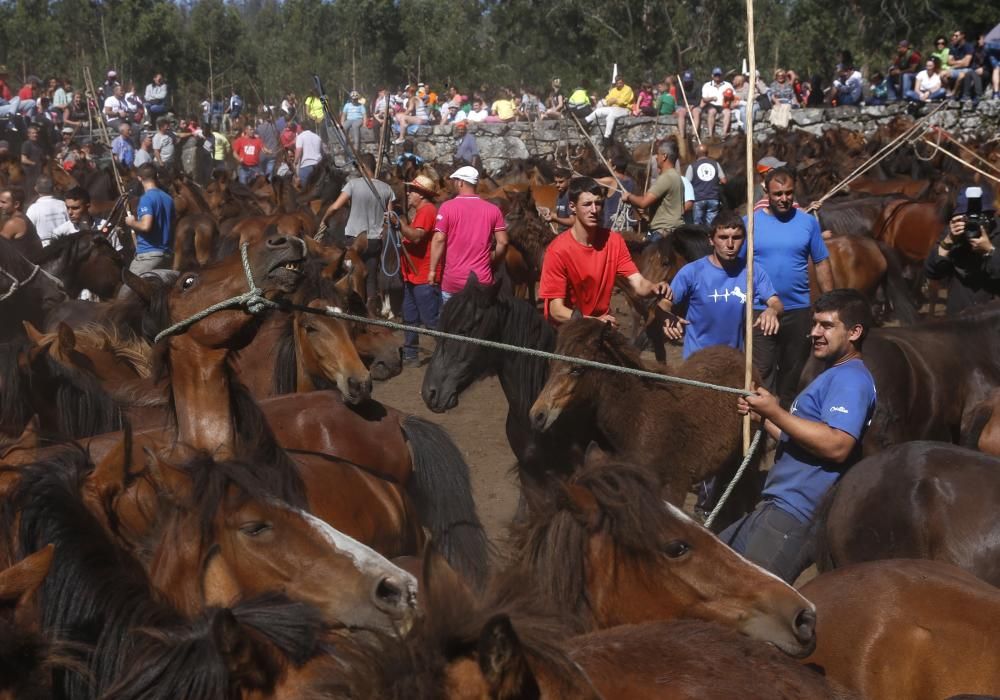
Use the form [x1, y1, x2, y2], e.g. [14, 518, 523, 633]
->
[538, 177, 673, 326]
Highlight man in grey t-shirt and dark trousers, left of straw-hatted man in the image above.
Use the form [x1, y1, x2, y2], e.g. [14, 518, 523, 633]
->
[323, 153, 396, 314]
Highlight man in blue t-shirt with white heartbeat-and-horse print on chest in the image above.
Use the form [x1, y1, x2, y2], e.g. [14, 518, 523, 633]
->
[663, 211, 782, 360]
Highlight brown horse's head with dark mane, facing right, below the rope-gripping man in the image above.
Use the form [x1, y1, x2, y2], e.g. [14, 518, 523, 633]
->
[500, 455, 816, 657]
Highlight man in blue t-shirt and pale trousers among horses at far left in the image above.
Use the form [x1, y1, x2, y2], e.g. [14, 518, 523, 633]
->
[125, 163, 177, 275]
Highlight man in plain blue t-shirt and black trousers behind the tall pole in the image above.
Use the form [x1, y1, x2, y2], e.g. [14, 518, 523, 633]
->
[741, 167, 833, 406]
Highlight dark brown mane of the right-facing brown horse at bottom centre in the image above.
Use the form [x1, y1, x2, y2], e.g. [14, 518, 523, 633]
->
[508, 463, 666, 633]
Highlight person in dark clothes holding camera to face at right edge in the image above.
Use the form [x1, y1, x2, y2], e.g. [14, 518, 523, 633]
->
[924, 187, 1000, 315]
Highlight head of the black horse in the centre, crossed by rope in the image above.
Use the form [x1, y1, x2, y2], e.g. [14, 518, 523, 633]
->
[420, 273, 501, 413]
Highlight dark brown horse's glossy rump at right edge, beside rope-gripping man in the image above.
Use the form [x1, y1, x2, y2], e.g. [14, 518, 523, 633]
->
[816, 442, 1000, 585]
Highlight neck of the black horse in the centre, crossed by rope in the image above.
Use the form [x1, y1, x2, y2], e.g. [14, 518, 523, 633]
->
[497, 299, 556, 419]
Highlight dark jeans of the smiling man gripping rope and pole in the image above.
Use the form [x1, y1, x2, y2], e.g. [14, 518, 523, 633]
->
[719, 501, 813, 583]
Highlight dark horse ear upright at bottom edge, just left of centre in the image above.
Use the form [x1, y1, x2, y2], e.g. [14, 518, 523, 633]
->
[477, 615, 541, 700]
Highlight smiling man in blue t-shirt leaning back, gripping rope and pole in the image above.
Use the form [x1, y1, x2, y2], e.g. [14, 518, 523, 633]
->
[719, 289, 875, 583]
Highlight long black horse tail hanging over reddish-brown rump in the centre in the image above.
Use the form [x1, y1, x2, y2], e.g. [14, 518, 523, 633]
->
[401, 416, 490, 588]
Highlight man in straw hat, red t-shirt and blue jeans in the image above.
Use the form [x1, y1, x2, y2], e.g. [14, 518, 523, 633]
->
[399, 175, 442, 366]
